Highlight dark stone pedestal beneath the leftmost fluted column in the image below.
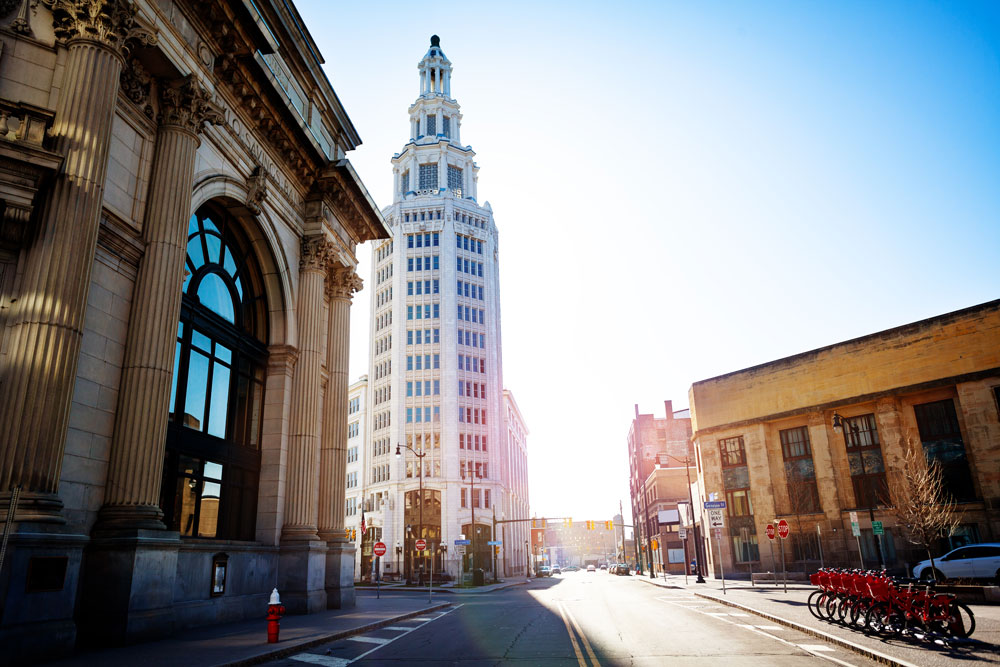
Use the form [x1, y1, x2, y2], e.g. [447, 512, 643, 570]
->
[0, 524, 88, 664]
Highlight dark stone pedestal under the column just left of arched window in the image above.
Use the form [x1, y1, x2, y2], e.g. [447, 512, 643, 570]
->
[79, 529, 181, 646]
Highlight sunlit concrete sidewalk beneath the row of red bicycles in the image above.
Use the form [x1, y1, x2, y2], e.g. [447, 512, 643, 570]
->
[633, 575, 1000, 665]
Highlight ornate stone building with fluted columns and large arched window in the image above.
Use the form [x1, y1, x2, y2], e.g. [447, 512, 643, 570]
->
[0, 0, 388, 659]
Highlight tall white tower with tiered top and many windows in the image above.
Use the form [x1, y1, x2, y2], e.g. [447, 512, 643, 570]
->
[359, 35, 512, 576]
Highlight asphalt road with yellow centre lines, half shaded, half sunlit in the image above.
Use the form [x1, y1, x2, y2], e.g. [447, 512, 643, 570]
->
[267, 572, 875, 667]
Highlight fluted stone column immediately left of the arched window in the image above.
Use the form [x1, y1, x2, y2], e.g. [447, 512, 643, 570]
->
[99, 77, 222, 528]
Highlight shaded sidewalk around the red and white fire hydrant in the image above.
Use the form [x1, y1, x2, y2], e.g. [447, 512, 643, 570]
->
[45, 594, 451, 667]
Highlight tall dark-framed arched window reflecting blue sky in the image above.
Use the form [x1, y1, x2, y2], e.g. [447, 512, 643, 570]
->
[160, 205, 267, 540]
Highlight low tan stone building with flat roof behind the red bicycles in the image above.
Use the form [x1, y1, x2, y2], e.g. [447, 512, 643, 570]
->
[690, 301, 1000, 573]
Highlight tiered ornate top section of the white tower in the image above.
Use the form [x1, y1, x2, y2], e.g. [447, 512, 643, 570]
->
[392, 35, 479, 201]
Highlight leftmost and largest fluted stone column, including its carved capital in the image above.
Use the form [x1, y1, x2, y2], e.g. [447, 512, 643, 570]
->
[0, 0, 153, 523]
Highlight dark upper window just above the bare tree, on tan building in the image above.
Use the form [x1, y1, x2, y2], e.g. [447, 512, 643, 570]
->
[913, 398, 976, 500]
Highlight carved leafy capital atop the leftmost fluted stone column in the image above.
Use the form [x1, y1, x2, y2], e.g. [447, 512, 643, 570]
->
[42, 0, 156, 55]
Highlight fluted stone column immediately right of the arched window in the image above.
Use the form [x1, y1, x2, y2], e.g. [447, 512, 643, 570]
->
[281, 237, 335, 542]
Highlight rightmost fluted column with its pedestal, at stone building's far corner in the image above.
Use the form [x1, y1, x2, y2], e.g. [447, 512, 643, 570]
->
[319, 266, 362, 609]
